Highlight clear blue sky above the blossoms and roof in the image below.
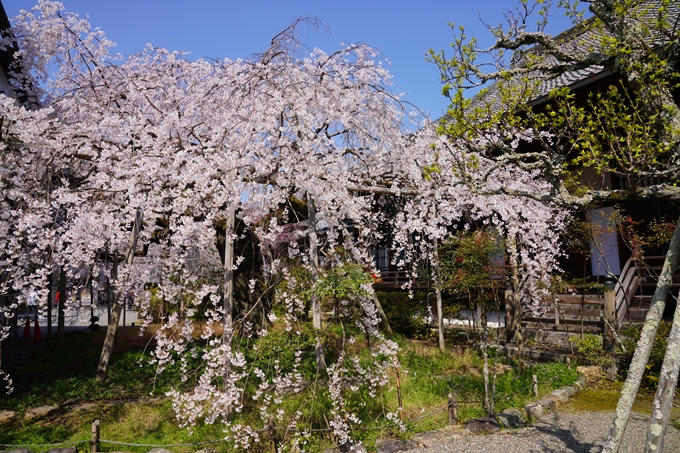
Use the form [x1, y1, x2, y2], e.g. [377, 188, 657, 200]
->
[2, 0, 570, 118]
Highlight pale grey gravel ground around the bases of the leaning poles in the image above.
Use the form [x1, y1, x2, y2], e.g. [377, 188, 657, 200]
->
[409, 412, 680, 453]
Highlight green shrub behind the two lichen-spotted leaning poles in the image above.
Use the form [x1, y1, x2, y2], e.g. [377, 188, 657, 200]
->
[620, 321, 680, 392]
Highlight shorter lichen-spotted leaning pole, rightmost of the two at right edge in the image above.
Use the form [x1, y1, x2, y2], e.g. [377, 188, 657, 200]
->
[645, 278, 680, 453]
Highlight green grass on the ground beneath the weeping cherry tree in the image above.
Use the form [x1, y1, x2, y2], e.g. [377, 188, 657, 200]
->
[0, 328, 576, 453]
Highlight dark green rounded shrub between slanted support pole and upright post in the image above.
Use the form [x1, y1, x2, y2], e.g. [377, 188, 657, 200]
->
[376, 292, 430, 338]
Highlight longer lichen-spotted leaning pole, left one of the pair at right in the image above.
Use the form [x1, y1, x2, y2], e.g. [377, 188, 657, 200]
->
[602, 215, 680, 453]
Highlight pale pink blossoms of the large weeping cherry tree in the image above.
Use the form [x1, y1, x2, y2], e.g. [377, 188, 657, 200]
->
[0, 0, 564, 448]
